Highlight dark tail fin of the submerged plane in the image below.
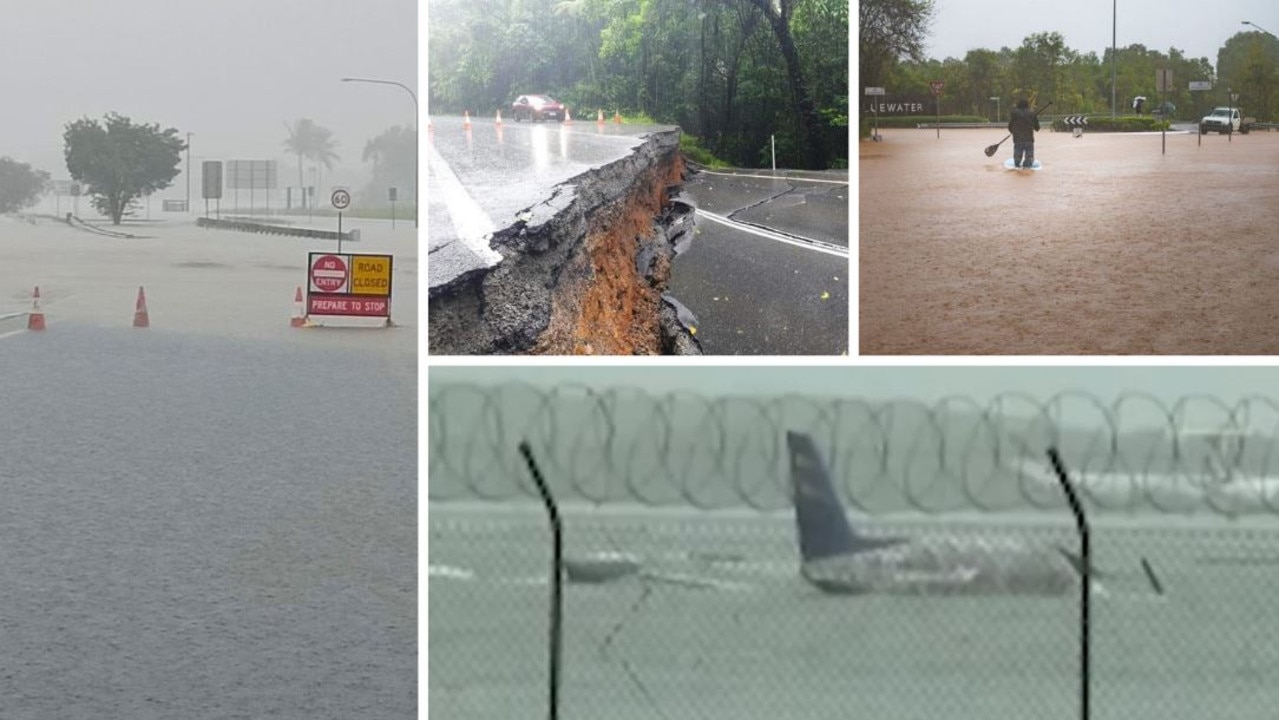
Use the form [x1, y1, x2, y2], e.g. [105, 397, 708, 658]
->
[787, 432, 904, 561]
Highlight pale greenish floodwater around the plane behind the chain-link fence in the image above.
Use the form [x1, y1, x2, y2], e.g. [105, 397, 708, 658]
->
[427, 501, 1279, 720]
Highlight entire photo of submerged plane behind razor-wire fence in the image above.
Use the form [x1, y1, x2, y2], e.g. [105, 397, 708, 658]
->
[427, 367, 1279, 720]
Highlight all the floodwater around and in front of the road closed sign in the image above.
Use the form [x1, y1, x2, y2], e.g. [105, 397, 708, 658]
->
[0, 219, 417, 719]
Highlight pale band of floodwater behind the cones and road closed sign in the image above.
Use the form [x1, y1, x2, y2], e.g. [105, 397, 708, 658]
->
[0, 213, 417, 350]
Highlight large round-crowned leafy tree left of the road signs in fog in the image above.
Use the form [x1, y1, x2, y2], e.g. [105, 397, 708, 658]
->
[63, 113, 187, 225]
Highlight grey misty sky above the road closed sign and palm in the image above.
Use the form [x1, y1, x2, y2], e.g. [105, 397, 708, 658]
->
[0, 0, 417, 196]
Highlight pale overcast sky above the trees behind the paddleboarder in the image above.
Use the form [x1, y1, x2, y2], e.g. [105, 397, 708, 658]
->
[925, 0, 1279, 67]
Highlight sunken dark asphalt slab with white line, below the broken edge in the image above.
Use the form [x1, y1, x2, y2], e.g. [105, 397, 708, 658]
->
[669, 170, 849, 356]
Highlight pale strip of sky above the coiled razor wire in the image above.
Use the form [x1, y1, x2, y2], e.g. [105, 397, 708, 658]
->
[428, 366, 1279, 411]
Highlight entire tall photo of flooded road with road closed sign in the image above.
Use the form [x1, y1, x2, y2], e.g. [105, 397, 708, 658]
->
[0, 0, 418, 719]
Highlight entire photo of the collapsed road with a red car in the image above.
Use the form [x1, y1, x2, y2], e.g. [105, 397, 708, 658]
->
[423, 0, 852, 356]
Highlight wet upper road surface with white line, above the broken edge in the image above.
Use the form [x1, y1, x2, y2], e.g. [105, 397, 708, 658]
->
[426, 118, 674, 288]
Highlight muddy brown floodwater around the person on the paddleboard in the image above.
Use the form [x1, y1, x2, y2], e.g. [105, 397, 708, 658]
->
[858, 129, 1279, 354]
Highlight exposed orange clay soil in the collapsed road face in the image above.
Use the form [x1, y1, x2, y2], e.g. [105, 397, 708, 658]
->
[536, 153, 683, 356]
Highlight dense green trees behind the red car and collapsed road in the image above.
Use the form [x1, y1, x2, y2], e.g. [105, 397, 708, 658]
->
[427, 0, 849, 168]
